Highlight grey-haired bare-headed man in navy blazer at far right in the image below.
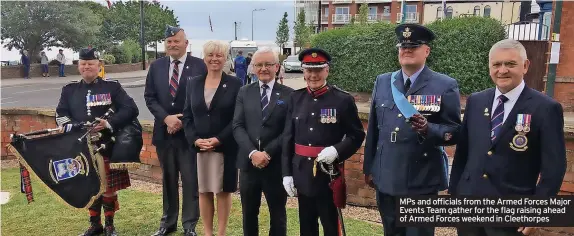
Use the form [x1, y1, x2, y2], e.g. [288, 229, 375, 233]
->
[449, 39, 566, 235]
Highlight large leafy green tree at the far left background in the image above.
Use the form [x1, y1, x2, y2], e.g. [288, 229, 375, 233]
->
[1, 1, 102, 60]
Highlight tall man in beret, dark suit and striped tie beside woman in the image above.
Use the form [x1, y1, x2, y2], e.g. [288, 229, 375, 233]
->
[144, 26, 207, 236]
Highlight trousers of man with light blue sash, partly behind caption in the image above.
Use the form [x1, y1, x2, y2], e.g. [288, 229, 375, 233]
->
[377, 191, 437, 236]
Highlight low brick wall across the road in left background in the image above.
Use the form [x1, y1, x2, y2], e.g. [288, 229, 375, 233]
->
[1, 60, 153, 79]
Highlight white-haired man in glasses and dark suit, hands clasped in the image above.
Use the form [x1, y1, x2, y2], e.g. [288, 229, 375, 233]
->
[233, 48, 293, 236]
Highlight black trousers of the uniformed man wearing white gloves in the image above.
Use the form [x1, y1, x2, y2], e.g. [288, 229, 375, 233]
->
[298, 185, 339, 236]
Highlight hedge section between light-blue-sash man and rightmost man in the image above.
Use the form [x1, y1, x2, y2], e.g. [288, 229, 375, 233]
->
[427, 17, 506, 94]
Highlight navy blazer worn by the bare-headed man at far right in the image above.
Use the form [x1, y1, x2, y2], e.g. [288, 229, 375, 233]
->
[449, 87, 566, 196]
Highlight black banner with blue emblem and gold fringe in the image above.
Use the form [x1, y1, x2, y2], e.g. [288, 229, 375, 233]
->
[8, 130, 106, 208]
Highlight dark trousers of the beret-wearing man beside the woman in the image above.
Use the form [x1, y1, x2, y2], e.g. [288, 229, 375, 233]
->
[156, 140, 199, 229]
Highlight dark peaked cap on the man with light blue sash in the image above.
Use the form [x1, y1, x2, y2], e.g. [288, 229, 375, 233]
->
[395, 24, 436, 48]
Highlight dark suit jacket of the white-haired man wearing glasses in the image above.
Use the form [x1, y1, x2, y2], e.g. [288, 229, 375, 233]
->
[233, 82, 293, 173]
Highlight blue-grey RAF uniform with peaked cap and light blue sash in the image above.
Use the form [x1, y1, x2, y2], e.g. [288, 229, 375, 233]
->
[363, 24, 461, 235]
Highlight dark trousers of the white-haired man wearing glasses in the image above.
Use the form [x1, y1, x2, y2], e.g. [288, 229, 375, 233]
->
[239, 169, 287, 236]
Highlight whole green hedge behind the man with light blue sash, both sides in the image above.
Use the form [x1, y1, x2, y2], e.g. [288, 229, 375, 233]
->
[311, 17, 506, 94]
